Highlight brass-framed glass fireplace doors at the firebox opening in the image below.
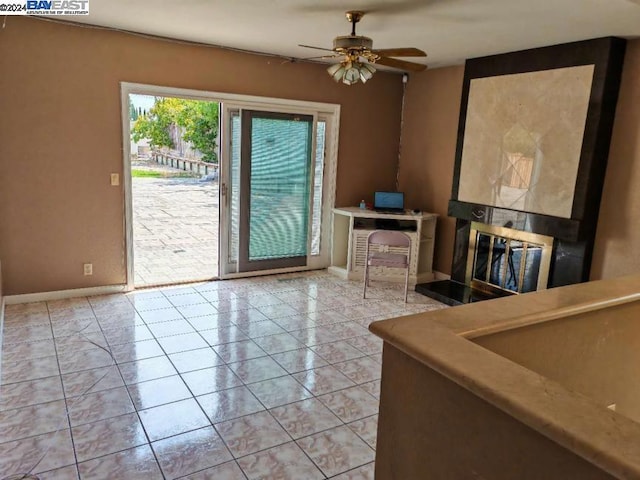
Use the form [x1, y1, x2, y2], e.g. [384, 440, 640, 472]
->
[465, 222, 553, 296]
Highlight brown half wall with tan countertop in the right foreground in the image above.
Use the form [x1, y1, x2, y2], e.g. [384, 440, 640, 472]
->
[369, 275, 640, 480]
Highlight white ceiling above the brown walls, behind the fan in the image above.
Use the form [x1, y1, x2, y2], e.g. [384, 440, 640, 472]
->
[66, 0, 640, 68]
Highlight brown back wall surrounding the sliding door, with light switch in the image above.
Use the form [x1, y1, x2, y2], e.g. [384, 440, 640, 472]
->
[0, 17, 402, 295]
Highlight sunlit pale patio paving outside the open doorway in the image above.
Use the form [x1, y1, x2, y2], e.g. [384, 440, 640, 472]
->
[132, 162, 218, 288]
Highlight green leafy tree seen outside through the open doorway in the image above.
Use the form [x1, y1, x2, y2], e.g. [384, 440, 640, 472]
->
[131, 97, 218, 163]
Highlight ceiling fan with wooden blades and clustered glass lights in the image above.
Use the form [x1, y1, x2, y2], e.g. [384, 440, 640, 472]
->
[298, 10, 427, 85]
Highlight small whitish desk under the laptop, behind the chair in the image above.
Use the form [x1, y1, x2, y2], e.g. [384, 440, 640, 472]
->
[329, 207, 438, 286]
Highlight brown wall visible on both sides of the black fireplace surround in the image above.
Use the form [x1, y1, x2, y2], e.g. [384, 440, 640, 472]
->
[399, 40, 640, 280]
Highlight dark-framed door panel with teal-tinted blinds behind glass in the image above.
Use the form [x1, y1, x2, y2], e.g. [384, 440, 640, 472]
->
[238, 110, 313, 272]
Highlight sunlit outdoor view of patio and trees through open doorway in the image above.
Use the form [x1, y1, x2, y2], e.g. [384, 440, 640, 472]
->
[129, 94, 219, 288]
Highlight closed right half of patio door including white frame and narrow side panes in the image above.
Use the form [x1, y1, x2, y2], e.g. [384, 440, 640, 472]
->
[220, 107, 331, 278]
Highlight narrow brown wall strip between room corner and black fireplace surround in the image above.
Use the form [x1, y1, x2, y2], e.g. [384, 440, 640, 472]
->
[398, 66, 464, 274]
